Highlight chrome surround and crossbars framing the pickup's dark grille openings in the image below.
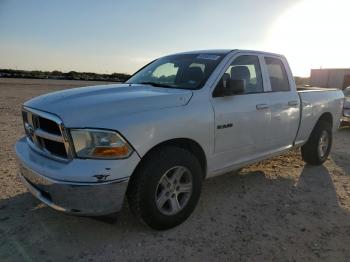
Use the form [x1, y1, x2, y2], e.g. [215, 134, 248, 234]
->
[22, 106, 74, 161]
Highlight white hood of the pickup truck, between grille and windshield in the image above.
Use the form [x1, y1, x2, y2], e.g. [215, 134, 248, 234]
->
[24, 84, 192, 127]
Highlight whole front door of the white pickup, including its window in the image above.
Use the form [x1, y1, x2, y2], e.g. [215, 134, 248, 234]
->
[212, 54, 271, 172]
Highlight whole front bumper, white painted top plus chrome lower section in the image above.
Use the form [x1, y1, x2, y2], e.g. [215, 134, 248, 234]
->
[16, 139, 138, 216]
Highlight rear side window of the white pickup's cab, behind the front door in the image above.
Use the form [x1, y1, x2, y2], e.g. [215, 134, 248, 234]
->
[265, 57, 290, 92]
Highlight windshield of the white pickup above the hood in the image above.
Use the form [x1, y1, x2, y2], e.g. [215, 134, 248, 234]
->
[126, 54, 223, 89]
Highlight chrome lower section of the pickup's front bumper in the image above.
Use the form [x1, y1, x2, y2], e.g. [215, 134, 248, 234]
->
[19, 164, 128, 216]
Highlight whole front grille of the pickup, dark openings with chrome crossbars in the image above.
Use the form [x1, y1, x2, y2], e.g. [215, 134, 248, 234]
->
[22, 108, 71, 159]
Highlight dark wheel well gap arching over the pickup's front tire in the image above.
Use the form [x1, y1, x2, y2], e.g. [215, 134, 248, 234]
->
[136, 138, 207, 177]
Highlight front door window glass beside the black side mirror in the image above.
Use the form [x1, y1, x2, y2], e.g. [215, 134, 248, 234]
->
[223, 55, 264, 94]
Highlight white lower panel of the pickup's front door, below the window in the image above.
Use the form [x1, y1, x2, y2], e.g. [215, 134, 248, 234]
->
[208, 93, 271, 172]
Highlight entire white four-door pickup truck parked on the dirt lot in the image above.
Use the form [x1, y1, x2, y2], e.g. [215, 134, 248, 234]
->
[15, 50, 344, 229]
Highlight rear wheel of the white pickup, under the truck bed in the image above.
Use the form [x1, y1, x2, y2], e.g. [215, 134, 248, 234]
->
[301, 121, 333, 166]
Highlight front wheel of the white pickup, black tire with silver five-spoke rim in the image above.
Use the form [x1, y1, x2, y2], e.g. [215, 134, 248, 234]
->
[127, 146, 203, 230]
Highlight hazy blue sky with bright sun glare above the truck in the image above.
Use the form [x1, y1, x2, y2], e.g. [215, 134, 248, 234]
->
[0, 0, 350, 76]
